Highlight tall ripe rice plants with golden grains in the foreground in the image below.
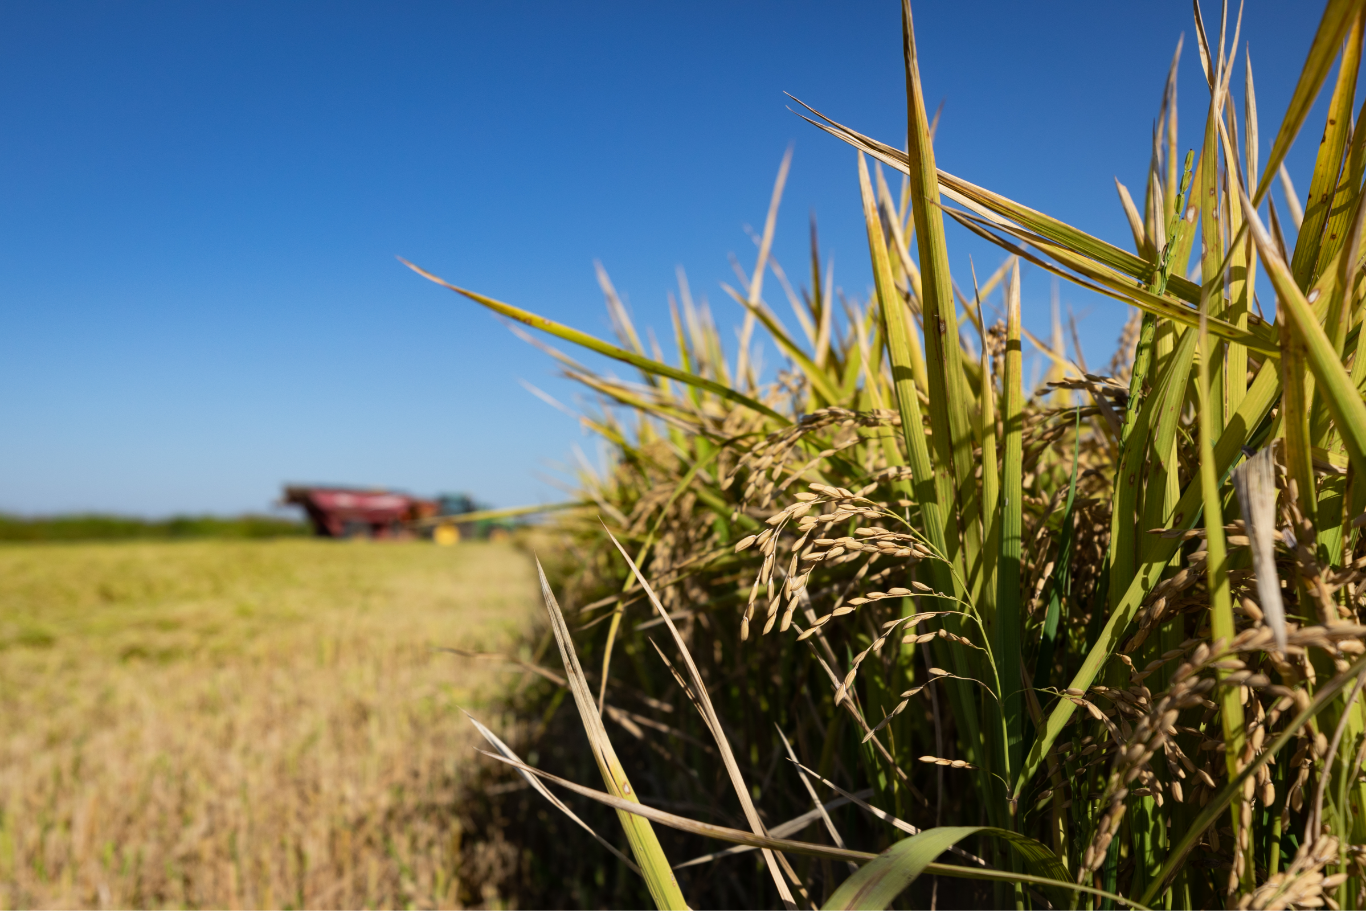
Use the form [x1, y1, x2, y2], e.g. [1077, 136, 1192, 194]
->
[419, 0, 1366, 911]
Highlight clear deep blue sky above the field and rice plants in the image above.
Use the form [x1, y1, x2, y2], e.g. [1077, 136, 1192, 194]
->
[0, 0, 1338, 515]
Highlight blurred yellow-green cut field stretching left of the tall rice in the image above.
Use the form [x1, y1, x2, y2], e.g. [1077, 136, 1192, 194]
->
[0, 539, 540, 911]
